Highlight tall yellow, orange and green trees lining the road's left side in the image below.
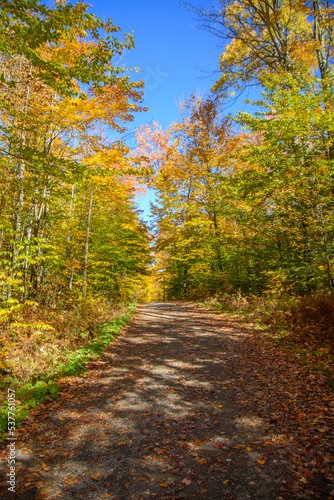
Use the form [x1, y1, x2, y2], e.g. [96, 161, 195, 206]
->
[0, 1, 149, 303]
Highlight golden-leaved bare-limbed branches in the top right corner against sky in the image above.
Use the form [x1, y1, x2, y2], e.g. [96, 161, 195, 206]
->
[183, 0, 334, 93]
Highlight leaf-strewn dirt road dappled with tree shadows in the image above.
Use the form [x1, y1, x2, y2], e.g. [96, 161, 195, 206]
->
[2, 303, 331, 500]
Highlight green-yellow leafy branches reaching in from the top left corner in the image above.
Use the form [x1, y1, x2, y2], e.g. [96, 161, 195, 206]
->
[0, 0, 138, 95]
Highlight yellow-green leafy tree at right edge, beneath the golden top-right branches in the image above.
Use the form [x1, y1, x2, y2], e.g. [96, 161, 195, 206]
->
[238, 68, 334, 293]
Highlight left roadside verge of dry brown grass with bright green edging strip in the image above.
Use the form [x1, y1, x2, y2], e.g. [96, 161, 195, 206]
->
[0, 299, 136, 438]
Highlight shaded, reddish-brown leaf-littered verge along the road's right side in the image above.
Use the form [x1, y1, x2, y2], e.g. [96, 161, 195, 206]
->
[200, 294, 334, 390]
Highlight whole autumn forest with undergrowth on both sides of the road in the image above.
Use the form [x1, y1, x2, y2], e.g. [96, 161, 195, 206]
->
[0, 0, 334, 426]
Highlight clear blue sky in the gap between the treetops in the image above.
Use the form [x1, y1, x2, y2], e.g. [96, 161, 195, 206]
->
[86, 0, 250, 220]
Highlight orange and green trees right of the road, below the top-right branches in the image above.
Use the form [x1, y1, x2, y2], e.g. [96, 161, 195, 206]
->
[146, 71, 334, 299]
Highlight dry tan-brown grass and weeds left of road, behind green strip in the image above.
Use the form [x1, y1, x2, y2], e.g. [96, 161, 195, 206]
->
[1, 298, 123, 383]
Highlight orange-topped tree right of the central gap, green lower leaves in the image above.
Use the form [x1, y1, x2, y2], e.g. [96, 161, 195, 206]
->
[138, 96, 245, 297]
